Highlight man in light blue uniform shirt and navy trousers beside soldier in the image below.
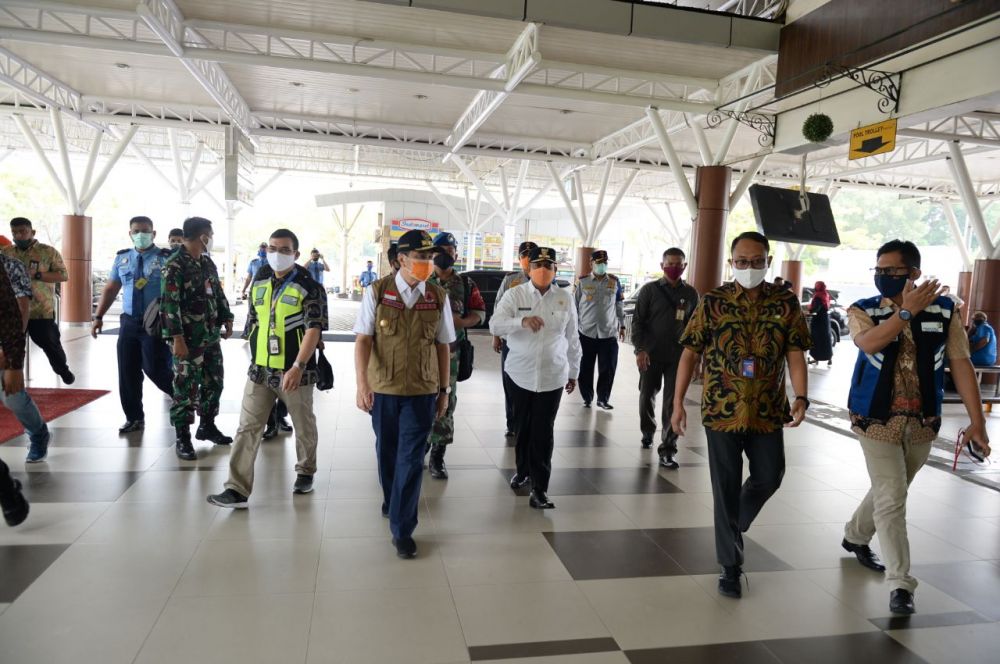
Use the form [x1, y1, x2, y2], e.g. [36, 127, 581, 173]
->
[90, 217, 173, 434]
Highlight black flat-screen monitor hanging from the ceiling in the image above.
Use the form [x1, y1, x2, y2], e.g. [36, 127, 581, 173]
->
[749, 184, 840, 247]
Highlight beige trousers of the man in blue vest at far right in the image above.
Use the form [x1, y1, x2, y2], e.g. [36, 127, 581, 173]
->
[844, 427, 931, 593]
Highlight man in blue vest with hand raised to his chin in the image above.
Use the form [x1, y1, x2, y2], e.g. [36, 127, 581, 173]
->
[842, 240, 990, 614]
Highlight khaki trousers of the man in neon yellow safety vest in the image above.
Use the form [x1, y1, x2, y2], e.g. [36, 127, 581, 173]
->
[226, 379, 319, 496]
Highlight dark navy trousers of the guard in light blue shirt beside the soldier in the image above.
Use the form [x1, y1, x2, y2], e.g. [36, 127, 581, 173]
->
[118, 314, 174, 421]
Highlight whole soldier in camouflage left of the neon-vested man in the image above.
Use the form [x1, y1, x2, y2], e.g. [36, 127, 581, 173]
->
[160, 217, 233, 461]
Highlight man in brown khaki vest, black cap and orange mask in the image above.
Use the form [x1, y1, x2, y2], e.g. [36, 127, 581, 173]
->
[354, 230, 455, 558]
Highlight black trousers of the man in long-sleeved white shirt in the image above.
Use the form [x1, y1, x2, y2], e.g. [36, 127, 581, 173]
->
[511, 381, 563, 491]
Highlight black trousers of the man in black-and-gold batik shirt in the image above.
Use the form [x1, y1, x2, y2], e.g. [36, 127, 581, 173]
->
[705, 428, 785, 567]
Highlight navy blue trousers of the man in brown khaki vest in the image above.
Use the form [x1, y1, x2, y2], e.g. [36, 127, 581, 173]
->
[372, 393, 437, 539]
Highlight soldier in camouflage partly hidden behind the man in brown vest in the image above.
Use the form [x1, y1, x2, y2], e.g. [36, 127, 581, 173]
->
[427, 233, 486, 480]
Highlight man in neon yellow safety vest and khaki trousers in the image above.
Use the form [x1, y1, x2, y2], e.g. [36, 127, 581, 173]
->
[208, 228, 327, 508]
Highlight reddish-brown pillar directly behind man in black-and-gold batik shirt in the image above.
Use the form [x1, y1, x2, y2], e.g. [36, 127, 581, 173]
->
[689, 166, 732, 293]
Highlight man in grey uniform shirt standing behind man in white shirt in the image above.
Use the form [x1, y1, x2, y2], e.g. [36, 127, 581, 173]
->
[575, 251, 625, 410]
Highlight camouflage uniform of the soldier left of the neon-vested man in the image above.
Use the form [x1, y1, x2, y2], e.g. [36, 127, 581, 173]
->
[160, 247, 233, 427]
